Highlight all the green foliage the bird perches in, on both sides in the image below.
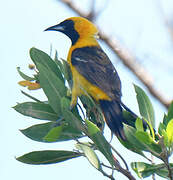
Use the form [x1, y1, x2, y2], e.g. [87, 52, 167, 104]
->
[14, 48, 173, 179]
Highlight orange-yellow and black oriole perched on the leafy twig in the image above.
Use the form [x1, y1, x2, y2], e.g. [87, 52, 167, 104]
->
[45, 17, 132, 140]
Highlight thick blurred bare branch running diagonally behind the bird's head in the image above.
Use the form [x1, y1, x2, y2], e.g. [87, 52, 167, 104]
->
[60, 0, 171, 108]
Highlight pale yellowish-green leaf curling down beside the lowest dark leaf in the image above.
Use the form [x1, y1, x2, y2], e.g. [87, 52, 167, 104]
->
[76, 143, 101, 170]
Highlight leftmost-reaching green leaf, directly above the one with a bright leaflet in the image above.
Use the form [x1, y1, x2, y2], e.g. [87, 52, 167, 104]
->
[14, 102, 58, 121]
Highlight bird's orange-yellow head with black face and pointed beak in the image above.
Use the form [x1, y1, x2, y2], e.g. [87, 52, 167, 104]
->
[45, 17, 98, 45]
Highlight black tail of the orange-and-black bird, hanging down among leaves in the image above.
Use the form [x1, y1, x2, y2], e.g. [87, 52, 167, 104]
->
[100, 100, 126, 140]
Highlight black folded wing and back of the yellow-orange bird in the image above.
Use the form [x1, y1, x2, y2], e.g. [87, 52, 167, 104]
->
[71, 46, 121, 101]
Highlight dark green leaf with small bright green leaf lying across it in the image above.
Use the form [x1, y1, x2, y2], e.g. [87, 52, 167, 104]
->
[20, 122, 83, 143]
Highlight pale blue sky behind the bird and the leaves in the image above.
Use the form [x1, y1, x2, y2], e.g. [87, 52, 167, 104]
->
[0, 0, 173, 180]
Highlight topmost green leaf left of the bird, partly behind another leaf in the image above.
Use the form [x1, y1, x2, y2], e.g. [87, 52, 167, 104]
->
[30, 47, 64, 82]
